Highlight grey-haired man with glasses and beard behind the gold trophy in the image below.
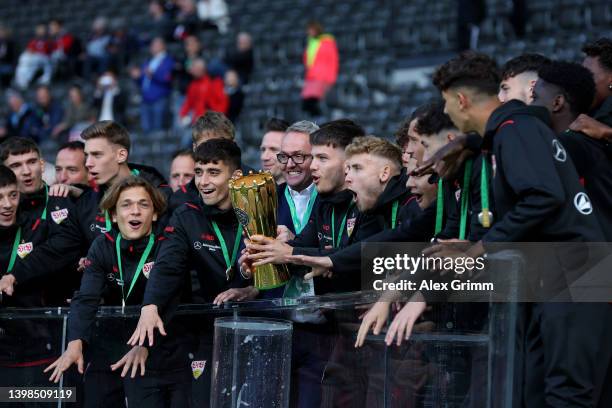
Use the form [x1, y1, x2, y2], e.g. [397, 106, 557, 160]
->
[276, 120, 319, 241]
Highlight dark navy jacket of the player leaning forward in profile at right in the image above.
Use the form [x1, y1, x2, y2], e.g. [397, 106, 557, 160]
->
[482, 101, 603, 242]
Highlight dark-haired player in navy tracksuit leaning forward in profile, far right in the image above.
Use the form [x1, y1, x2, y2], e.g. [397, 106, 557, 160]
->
[429, 53, 612, 407]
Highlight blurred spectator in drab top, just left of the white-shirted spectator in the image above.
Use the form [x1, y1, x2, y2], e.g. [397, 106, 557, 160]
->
[51, 84, 95, 141]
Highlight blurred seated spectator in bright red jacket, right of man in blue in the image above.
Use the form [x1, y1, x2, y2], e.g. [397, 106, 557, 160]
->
[179, 58, 229, 124]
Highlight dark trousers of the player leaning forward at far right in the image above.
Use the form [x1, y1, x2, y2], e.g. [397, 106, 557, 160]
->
[523, 303, 612, 408]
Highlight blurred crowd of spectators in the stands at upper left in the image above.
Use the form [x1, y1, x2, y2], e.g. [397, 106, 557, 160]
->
[0, 0, 254, 143]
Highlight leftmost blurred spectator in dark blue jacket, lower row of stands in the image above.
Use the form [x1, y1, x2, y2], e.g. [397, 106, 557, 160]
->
[0, 90, 42, 142]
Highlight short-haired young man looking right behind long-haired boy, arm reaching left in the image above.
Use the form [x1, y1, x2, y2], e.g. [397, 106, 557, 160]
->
[2, 121, 169, 298]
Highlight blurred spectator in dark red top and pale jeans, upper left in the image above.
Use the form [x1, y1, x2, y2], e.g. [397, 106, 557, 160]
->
[15, 24, 51, 90]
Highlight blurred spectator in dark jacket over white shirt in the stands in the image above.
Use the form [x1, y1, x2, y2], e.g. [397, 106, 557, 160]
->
[94, 70, 127, 125]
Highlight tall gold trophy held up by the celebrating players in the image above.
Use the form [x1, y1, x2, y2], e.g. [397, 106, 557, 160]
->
[229, 171, 290, 289]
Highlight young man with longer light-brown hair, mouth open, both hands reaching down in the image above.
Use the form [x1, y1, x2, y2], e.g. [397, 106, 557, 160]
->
[45, 176, 193, 407]
